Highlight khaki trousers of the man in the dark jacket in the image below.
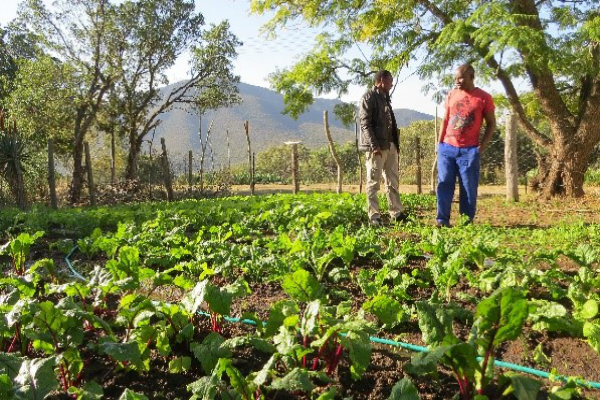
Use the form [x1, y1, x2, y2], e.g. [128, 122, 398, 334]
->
[367, 144, 404, 219]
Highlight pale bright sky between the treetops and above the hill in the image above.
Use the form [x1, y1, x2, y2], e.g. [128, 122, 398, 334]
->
[0, 0, 435, 114]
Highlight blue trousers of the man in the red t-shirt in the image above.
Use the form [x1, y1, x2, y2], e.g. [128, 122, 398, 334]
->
[436, 143, 479, 225]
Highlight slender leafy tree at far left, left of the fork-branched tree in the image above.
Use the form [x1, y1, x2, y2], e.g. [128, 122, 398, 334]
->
[20, 0, 122, 203]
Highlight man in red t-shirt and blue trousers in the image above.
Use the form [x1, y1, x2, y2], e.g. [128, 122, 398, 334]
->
[436, 64, 496, 226]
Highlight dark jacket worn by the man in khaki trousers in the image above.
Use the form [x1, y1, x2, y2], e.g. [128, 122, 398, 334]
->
[358, 86, 400, 151]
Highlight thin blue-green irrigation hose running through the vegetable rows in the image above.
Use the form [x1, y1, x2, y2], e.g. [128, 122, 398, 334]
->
[65, 246, 600, 389]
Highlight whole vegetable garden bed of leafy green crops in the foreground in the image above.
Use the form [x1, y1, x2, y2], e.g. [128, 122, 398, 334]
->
[0, 194, 600, 400]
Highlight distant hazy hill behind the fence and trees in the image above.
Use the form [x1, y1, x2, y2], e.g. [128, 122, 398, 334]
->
[155, 83, 433, 164]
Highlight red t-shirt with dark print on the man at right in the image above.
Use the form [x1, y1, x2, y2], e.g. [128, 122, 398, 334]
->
[443, 88, 494, 147]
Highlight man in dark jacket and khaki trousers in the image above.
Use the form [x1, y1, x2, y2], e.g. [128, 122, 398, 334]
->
[359, 70, 406, 226]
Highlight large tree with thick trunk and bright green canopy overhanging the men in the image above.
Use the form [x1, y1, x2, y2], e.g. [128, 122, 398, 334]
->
[252, 0, 600, 197]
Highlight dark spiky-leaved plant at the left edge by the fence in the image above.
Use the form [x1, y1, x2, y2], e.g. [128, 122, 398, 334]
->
[0, 111, 29, 209]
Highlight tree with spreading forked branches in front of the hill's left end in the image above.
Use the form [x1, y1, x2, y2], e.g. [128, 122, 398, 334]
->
[102, 0, 239, 179]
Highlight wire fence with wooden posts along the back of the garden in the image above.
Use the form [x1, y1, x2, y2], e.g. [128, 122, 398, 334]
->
[0, 117, 600, 206]
